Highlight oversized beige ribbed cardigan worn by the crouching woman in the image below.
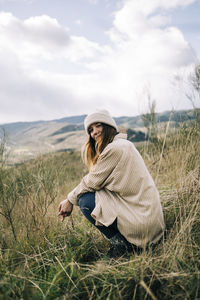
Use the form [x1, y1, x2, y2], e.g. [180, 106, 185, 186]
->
[67, 134, 165, 247]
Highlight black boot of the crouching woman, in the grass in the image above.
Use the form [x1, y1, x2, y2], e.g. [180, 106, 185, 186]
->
[107, 233, 133, 258]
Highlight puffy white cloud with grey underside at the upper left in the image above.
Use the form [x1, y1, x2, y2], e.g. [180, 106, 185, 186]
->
[0, 13, 70, 65]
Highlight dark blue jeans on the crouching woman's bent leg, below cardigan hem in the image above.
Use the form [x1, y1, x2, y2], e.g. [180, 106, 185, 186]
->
[79, 193, 119, 239]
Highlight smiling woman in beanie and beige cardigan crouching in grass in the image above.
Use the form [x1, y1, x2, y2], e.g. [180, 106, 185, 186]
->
[59, 110, 165, 257]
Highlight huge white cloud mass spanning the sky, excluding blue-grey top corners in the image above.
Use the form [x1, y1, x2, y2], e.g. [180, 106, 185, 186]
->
[0, 0, 198, 122]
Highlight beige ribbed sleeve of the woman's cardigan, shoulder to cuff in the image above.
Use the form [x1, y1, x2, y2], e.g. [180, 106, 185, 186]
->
[67, 144, 121, 205]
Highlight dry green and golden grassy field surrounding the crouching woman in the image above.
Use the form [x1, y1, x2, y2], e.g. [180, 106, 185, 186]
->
[0, 123, 200, 300]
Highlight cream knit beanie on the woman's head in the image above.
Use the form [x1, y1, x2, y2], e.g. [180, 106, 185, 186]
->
[84, 110, 118, 133]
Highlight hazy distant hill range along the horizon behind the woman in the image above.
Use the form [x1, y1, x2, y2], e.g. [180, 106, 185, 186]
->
[0, 110, 195, 162]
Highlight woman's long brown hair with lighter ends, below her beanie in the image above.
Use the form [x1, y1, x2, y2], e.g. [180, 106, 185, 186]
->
[82, 123, 117, 170]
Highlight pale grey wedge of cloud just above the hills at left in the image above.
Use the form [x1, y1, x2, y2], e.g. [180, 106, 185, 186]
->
[0, 47, 72, 122]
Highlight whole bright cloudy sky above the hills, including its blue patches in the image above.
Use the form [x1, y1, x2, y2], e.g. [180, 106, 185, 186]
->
[0, 0, 200, 124]
